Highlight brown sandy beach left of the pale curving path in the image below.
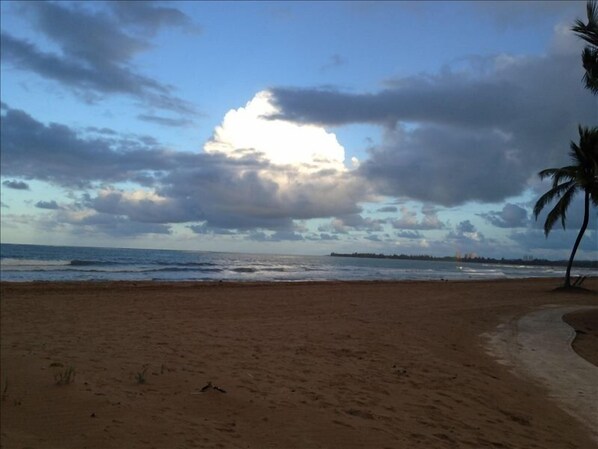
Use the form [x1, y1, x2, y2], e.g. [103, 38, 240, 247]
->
[0, 280, 598, 449]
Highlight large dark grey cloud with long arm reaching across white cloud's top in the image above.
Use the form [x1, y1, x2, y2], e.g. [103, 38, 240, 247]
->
[272, 40, 596, 206]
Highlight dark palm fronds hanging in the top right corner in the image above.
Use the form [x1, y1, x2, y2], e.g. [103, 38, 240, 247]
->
[571, 0, 598, 94]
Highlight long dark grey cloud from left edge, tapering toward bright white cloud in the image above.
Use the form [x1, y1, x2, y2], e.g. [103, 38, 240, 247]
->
[0, 109, 197, 186]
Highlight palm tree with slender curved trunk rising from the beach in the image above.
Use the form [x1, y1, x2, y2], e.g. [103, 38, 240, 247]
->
[534, 126, 598, 288]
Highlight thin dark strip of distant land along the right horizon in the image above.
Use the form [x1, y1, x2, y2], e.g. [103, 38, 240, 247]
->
[330, 252, 598, 269]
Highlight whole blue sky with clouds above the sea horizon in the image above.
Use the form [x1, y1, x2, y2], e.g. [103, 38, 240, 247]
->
[0, 1, 598, 259]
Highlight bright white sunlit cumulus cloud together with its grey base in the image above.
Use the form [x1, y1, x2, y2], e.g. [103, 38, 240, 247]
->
[175, 92, 369, 230]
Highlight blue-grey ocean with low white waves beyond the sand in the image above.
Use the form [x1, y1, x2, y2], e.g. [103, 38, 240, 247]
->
[0, 244, 598, 282]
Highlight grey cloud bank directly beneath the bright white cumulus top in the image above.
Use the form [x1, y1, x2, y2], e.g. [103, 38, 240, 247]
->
[160, 155, 364, 230]
